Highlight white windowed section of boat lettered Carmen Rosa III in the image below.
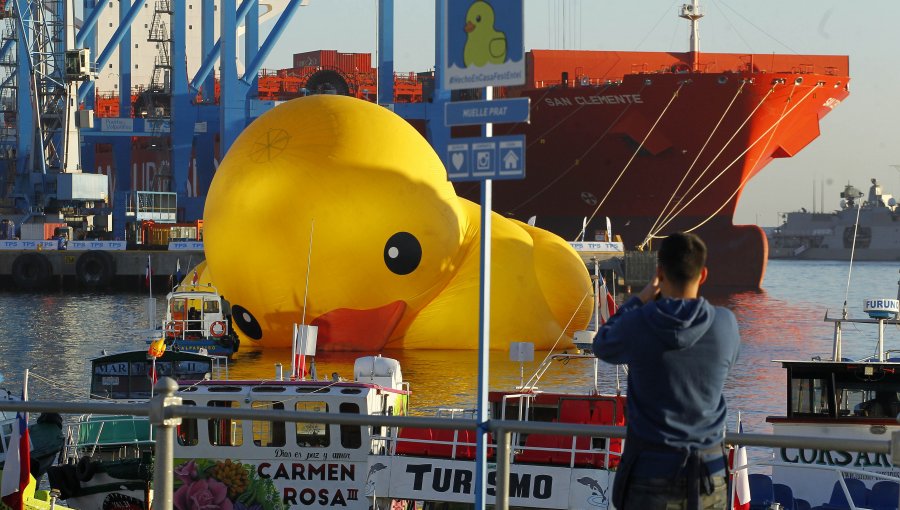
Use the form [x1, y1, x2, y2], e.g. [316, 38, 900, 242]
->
[168, 356, 409, 509]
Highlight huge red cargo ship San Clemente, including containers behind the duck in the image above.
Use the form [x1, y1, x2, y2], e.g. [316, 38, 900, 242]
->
[97, 11, 849, 289]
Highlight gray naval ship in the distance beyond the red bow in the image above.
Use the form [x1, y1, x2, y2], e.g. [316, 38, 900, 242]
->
[769, 179, 900, 260]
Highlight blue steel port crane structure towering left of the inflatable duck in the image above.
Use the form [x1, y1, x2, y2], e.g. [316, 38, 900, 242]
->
[0, 0, 308, 238]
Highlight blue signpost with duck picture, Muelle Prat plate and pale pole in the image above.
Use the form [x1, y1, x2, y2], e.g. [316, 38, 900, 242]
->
[442, 0, 528, 509]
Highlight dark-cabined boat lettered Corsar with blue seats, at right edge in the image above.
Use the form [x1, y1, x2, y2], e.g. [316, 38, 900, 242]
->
[750, 282, 900, 510]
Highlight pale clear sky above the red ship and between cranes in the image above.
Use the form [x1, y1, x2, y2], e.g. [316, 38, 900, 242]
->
[263, 0, 900, 226]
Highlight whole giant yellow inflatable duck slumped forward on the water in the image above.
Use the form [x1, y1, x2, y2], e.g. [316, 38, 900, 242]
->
[204, 95, 592, 351]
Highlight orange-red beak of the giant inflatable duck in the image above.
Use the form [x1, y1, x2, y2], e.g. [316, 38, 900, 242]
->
[312, 301, 406, 352]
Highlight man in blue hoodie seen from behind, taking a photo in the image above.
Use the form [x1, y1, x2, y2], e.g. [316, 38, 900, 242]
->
[594, 232, 740, 510]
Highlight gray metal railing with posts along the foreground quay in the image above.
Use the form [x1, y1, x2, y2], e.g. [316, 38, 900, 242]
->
[0, 377, 900, 510]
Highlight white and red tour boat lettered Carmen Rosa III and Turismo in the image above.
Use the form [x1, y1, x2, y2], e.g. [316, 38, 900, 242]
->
[163, 344, 625, 509]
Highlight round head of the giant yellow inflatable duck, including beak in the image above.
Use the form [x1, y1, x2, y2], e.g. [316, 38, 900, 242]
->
[204, 95, 467, 350]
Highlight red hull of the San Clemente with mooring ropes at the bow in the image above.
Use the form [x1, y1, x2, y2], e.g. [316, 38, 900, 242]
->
[457, 52, 848, 288]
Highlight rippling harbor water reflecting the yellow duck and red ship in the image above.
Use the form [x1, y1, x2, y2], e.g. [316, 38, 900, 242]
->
[0, 260, 900, 468]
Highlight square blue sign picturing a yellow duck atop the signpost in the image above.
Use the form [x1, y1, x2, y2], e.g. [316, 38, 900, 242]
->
[444, 0, 525, 90]
